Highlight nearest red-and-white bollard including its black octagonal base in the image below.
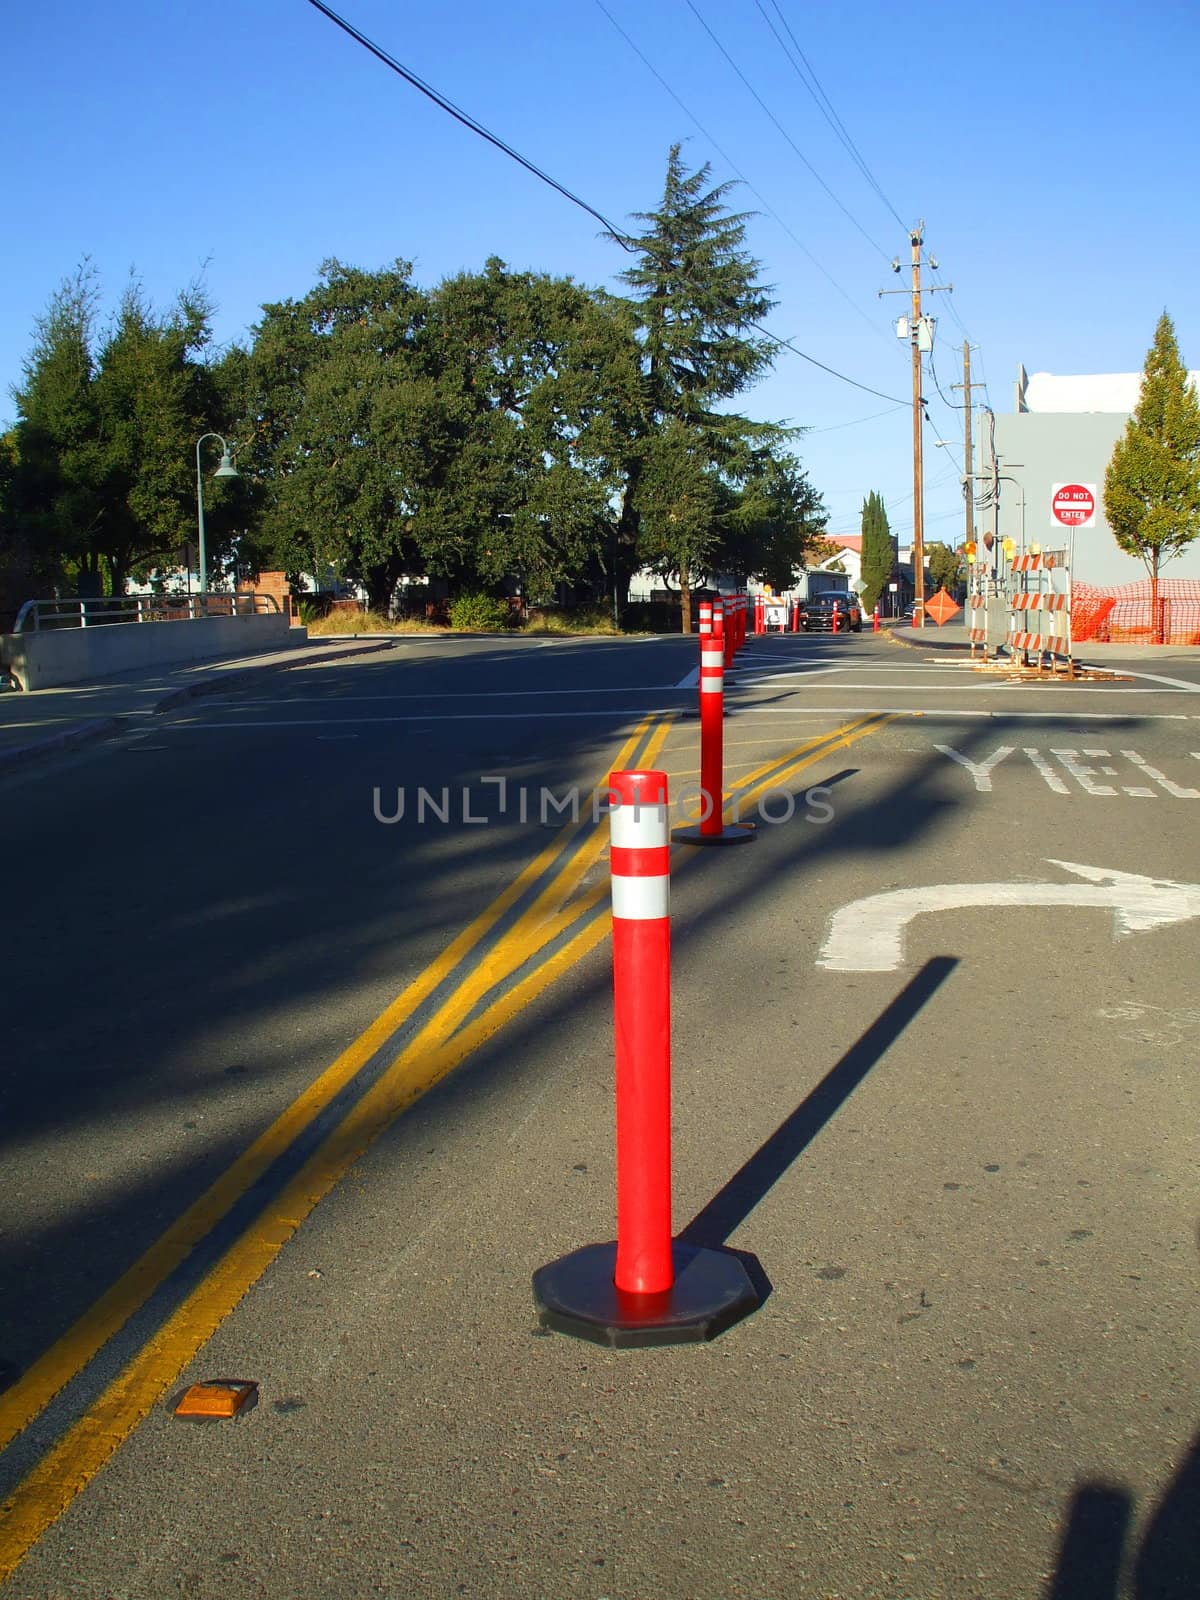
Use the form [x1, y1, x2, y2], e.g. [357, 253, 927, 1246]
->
[533, 768, 760, 1347]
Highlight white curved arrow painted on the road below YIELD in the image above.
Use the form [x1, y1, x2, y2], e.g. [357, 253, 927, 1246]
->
[816, 861, 1200, 973]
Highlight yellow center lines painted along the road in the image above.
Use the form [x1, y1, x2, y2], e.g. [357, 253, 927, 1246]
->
[0, 717, 888, 1582]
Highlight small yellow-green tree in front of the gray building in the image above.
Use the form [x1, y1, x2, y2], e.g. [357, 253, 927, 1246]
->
[1104, 312, 1200, 635]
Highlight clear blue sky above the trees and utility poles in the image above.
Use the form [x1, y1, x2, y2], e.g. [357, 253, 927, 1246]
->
[0, 0, 1200, 539]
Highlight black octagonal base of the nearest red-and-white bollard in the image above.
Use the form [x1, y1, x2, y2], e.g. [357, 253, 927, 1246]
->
[533, 1242, 762, 1350]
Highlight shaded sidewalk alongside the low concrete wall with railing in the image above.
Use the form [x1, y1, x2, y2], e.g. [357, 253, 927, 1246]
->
[0, 635, 394, 770]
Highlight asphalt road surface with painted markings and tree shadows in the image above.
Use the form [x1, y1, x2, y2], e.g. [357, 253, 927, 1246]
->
[0, 634, 1200, 1600]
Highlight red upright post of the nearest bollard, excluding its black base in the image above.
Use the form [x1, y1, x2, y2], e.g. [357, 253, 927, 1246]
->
[608, 771, 678, 1294]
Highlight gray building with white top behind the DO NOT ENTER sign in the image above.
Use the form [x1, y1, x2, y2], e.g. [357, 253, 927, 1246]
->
[974, 366, 1200, 587]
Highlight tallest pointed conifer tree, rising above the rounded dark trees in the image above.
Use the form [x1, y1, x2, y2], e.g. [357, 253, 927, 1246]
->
[619, 144, 784, 632]
